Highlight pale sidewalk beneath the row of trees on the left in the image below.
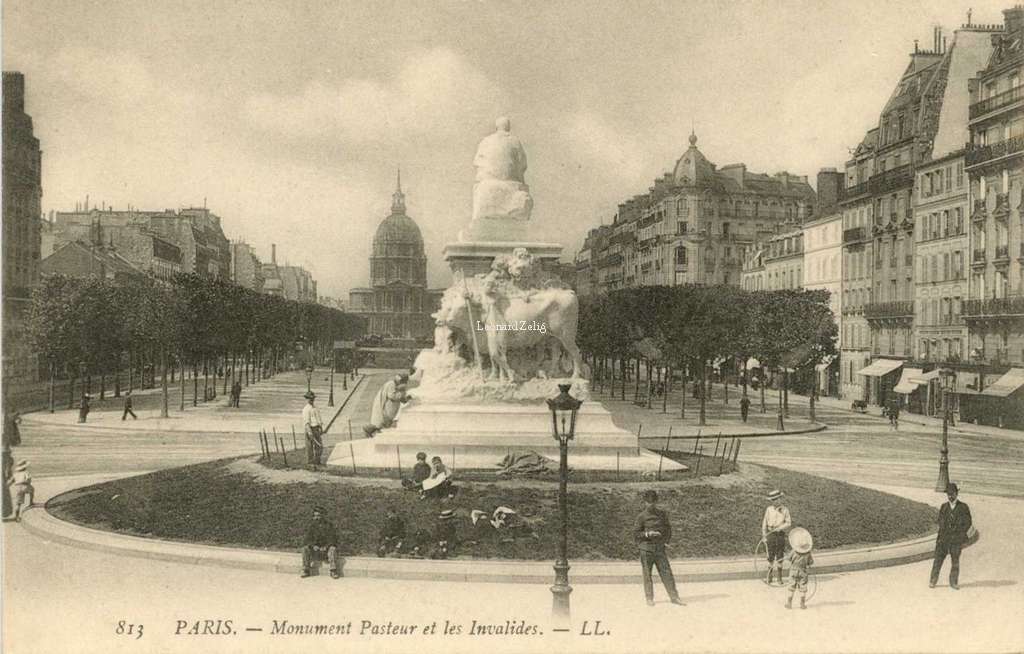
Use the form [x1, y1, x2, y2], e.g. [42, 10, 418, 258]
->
[22, 369, 365, 435]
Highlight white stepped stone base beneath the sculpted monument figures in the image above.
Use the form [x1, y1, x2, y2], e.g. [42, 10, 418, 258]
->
[328, 402, 686, 472]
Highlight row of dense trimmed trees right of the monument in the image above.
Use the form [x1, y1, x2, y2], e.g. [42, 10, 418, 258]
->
[579, 285, 838, 425]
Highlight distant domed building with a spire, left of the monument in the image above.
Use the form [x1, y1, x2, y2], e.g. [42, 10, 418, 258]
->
[349, 172, 441, 343]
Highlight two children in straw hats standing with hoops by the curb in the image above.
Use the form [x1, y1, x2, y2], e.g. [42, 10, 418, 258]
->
[761, 490, 814, 609]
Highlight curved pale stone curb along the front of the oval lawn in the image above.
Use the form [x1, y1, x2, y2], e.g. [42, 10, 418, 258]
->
[22, 499, 977, 584]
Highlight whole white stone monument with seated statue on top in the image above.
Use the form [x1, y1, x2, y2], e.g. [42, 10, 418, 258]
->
[329, 118, 684, 471]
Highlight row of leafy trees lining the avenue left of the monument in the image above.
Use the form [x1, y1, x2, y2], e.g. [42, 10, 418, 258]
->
[29, 274, 364, 417]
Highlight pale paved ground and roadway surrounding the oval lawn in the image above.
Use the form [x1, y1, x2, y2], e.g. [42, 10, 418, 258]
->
[4, 370, 1024, 653]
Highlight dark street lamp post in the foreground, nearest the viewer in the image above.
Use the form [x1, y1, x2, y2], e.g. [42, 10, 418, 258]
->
[548, 384, 583, 627]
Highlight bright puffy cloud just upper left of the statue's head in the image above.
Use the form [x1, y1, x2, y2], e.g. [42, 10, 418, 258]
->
[245, 48, 503, 143]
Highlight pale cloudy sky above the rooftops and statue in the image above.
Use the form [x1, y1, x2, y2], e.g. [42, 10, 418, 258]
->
[3, 0, 1013, 300]
